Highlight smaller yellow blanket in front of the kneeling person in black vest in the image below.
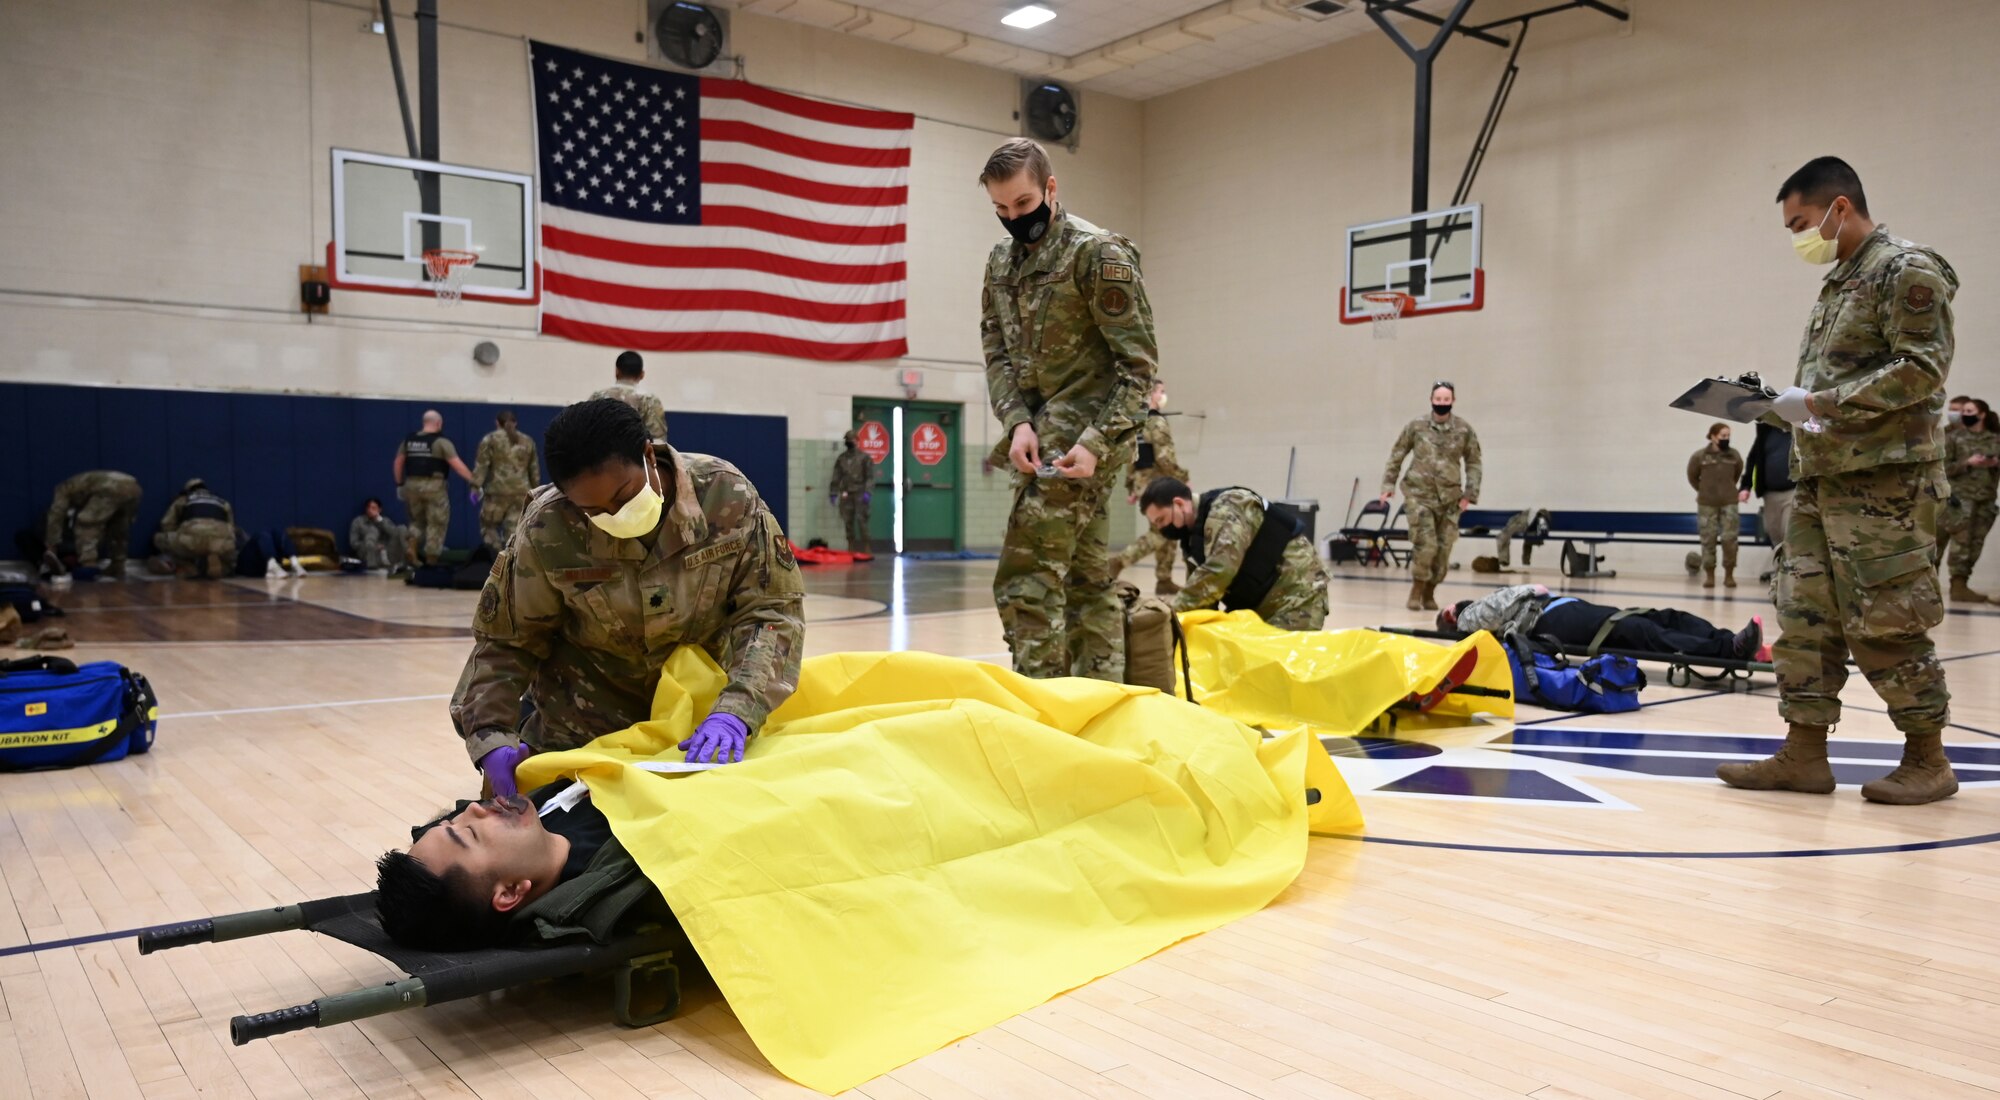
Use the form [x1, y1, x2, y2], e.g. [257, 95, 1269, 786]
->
[1180, 612, 1514, 736]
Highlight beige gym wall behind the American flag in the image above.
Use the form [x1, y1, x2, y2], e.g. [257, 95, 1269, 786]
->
[0, 0, 1142, 546]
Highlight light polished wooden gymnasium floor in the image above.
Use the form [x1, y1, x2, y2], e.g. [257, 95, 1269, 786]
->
[0, 554, 2000, 1100]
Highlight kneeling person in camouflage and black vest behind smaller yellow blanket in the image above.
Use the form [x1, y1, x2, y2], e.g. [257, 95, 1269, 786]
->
[1138, 478, 1326, 630]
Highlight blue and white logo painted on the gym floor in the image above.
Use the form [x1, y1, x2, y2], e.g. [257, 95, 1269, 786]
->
[1322, 724, 2000, 810]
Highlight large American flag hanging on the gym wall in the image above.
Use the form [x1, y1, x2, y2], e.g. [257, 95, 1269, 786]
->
[528, 42, 916, 360]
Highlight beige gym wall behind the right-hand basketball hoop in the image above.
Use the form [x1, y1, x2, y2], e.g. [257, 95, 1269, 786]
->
[1144, 0, 2000, 588]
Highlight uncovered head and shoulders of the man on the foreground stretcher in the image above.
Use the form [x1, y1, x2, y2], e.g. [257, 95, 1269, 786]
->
[376, 780, 672, 950]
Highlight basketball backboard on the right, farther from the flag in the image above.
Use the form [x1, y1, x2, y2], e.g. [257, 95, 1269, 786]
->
[1340, 202, 1486, 324]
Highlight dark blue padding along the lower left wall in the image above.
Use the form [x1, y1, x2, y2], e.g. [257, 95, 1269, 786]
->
[0, 382, 788, 558]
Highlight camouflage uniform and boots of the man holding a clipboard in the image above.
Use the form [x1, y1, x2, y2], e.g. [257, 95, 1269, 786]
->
[1716, 226, 1958, 804]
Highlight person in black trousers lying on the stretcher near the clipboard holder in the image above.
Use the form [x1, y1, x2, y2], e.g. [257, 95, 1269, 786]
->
[1438, 584, 1770, 660]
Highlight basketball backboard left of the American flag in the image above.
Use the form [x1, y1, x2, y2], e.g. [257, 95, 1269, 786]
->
[326, 148, 540, 306]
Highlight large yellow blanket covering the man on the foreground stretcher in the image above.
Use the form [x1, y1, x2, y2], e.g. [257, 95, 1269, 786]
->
[520, 646, 1362, 1092]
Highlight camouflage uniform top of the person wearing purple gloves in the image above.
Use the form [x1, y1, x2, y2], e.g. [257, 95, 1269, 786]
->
[452, 448, 806, 760]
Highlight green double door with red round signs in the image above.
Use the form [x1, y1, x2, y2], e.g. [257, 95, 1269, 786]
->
[854, 398, 964, 550]
